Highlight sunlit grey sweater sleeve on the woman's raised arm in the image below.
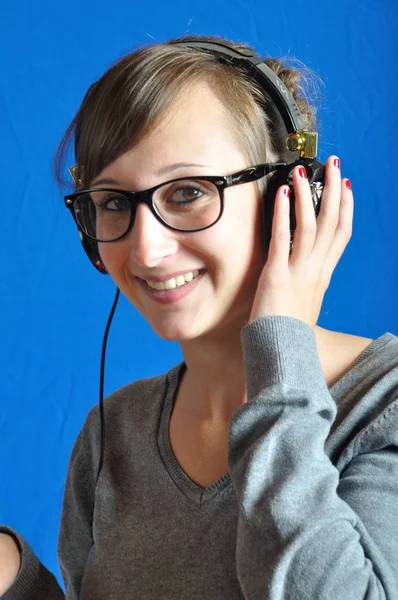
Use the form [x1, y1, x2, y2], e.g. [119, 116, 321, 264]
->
[228, 316, 398, 600]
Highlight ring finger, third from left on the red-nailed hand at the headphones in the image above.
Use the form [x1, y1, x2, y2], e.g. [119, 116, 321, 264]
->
[314, 156, 342, 257]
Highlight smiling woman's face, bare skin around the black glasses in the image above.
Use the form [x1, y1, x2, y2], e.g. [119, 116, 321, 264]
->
[92, 84, 262, 342]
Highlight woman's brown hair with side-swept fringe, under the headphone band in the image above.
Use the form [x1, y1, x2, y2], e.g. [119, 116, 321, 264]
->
[54, 36, 316, 192]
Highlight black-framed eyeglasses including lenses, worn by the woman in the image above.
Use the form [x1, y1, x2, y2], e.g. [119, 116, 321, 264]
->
[65, 163, 286, 242]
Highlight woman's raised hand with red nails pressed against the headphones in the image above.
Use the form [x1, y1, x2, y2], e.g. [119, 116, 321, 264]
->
[250, 156, 354, 327]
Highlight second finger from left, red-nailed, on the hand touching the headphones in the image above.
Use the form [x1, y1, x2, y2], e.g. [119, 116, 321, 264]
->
[291, 166, 316, 263]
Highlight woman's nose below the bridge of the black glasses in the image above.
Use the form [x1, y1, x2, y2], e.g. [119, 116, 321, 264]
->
[129, 203, 178, 268]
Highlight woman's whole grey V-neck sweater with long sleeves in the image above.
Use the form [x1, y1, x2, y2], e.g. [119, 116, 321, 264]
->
[2, 317, 398, 600]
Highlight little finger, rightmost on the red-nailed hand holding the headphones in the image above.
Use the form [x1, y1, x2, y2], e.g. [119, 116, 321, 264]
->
[324, 179, 354, 272]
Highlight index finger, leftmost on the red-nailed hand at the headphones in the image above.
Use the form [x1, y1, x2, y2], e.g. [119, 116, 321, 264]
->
[267, 185, 291, 265]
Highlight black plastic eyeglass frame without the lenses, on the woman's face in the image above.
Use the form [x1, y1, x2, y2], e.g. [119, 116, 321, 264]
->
[64, 163, 287, 244]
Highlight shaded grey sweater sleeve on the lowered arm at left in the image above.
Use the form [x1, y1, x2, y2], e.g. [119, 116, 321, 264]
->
[0, 418, 94, 600]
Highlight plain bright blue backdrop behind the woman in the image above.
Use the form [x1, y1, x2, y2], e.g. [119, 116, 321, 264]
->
[0, 0, 398, 588]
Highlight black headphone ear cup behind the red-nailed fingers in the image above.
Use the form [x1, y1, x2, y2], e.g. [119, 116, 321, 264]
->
[263, 161, 325, 260]
